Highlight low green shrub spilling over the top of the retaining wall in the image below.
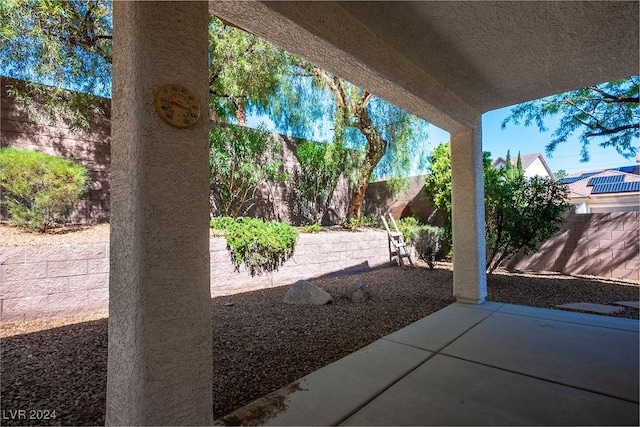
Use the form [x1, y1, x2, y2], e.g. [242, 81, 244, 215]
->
[216, 217, 298, 276]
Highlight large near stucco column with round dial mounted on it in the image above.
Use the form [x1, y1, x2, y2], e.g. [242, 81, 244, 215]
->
[106, 1, 213, 425]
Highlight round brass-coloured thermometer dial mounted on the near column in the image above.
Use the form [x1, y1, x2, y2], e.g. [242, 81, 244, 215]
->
[155, 83, 200, 129]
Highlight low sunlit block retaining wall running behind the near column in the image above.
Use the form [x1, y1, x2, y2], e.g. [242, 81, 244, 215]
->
[0, 231, 389, 323]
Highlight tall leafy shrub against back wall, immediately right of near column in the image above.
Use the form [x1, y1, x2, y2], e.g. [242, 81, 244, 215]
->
[209, 126, 289, 217]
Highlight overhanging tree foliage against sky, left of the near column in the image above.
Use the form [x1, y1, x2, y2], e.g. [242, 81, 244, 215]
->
[0, 0, 112, 129]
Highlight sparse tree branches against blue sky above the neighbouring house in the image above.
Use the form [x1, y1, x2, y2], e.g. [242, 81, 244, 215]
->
[502, 75, 640, 162]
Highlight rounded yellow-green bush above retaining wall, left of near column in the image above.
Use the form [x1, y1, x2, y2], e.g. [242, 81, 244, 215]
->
[0, 148, 87, 232]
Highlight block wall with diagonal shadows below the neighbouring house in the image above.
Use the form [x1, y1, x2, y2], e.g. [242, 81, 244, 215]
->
[507, 212, 640, 280]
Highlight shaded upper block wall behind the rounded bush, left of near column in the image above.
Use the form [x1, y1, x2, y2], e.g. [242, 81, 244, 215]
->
[0, 77, 111, 224]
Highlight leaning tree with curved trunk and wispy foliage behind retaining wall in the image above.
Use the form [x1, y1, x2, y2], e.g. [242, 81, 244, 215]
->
[289, 57, 426, 217]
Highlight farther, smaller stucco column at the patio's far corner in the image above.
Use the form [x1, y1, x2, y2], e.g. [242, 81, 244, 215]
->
[451, 116, 487, 304]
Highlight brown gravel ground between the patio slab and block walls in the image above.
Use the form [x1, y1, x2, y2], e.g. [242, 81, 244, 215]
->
[0, 226, 639, 425]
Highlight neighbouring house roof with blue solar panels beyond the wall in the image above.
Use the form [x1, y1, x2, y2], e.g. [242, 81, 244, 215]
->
[558, 165, 640, 199]
